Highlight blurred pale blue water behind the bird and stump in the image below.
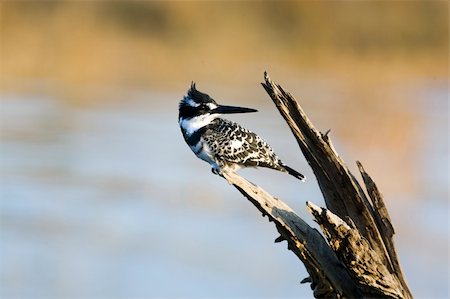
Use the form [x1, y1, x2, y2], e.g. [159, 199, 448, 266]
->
[0, 85, 449, 298]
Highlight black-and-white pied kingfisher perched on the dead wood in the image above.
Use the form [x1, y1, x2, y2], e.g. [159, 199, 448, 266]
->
[178, 83, 305, 181]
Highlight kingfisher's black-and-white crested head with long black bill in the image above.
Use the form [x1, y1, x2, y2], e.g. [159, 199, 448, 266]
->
[178, 82, 257, 122]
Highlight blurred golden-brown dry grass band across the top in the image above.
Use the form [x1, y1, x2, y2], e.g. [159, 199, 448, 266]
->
[0, 1, 448, 95]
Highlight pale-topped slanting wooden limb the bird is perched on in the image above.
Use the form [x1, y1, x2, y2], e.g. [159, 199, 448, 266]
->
[222, 172, 361, 298]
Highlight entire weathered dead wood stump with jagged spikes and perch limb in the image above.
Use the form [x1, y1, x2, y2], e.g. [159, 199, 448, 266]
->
[223, 73, 412, 298]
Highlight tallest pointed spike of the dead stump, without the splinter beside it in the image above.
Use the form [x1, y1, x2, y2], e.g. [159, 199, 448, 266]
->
[262, 73, 389, 264]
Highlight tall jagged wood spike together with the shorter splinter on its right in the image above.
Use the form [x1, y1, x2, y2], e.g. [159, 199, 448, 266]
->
[262, 72, 412, 298]
